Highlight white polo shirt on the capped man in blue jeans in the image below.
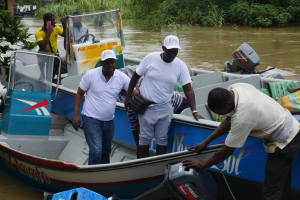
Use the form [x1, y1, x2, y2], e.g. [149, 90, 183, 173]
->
[79, 67, 130, 121]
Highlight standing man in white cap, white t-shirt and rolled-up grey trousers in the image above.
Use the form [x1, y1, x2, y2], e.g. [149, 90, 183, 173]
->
[125, 35, 202, 158]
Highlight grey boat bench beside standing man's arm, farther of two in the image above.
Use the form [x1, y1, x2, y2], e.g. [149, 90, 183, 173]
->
[191, 71, 224, 89]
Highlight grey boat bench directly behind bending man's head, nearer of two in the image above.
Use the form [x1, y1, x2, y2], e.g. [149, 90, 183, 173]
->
[194, 76, 262, 105]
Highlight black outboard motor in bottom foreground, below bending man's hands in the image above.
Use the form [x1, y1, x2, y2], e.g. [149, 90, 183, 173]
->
[134, 163, 217, 200]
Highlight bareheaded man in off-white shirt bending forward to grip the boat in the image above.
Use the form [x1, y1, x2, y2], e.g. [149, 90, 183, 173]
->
[183, 83, 300, 200]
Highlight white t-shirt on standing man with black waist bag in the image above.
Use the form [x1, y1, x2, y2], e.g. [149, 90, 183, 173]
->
[136, 52, 192, 103]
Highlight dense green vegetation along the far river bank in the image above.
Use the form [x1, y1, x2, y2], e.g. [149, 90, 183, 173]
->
[31, 0, 300, 31]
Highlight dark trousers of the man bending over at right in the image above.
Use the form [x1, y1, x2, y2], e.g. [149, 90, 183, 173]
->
[262, 131, 300, 200]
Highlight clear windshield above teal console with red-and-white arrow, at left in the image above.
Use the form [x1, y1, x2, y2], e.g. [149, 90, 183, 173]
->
[8, 52, 54, 93]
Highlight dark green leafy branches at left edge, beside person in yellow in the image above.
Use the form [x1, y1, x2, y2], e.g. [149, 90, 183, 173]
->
[0, 10, 37, 67]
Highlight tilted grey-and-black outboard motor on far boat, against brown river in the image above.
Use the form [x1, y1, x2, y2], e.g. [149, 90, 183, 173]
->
[224, 43, 260, 74]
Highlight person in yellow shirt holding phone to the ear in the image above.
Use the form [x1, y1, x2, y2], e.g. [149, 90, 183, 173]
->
[35, 13, 66, 81]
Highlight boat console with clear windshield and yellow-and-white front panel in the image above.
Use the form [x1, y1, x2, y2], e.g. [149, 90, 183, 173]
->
[66, 10, 125, 76]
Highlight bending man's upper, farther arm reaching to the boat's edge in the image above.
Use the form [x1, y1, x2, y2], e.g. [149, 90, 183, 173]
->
[189, 116, 231, 153]
